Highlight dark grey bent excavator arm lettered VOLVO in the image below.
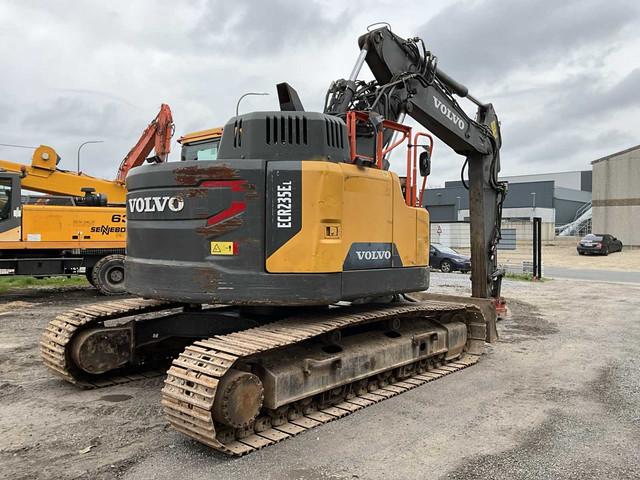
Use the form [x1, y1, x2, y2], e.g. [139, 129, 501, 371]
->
[325, 27, 507, 298]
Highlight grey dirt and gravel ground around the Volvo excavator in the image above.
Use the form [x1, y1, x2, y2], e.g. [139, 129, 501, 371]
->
[0, 278, 640, 480]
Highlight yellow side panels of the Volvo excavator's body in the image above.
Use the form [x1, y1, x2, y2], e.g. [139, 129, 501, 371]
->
[266, 161, 429, 273]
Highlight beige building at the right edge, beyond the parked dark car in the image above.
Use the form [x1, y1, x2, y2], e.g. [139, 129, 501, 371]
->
[591, 145, 640, 246]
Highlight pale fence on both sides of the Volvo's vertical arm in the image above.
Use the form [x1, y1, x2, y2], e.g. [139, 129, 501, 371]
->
[430, 217, 544, 277]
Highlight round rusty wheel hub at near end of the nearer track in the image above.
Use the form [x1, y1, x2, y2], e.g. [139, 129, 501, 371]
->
[213, 370, 264, 428]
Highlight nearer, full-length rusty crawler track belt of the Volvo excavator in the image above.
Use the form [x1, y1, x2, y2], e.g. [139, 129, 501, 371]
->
[162, 302, 486, 455]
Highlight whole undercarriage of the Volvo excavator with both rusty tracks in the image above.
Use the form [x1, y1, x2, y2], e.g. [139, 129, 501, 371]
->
[41, 297, 487, 455]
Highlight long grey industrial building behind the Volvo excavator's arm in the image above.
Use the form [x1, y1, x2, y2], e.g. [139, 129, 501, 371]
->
[424, 170, 592, 226]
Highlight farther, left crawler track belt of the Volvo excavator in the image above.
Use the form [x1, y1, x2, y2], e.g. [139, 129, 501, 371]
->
[40, 298, 180, 388]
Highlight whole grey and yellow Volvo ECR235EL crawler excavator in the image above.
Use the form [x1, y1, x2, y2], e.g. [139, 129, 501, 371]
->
[41, 25, 507, 455]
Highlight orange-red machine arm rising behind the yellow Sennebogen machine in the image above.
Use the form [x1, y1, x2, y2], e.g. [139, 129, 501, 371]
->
[116, 103, 174, 185]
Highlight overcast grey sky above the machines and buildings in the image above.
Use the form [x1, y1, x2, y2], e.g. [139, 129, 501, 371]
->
[0, 0, 640, 185]
